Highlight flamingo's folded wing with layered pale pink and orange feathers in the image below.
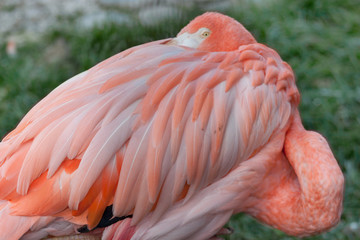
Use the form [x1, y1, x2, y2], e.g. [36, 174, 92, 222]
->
[0, 34, 299, 239]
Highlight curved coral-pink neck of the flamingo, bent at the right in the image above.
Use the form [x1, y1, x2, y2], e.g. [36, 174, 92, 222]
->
[248, 113, 344, 236]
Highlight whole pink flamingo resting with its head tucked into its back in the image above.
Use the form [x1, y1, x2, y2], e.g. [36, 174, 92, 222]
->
[0, 12, 344, 240]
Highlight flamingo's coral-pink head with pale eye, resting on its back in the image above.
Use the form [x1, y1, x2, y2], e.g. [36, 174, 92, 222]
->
[172, 12, 256, 52]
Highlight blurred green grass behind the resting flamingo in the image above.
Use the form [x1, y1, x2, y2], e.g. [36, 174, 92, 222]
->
[0, 0, 360, 240]
